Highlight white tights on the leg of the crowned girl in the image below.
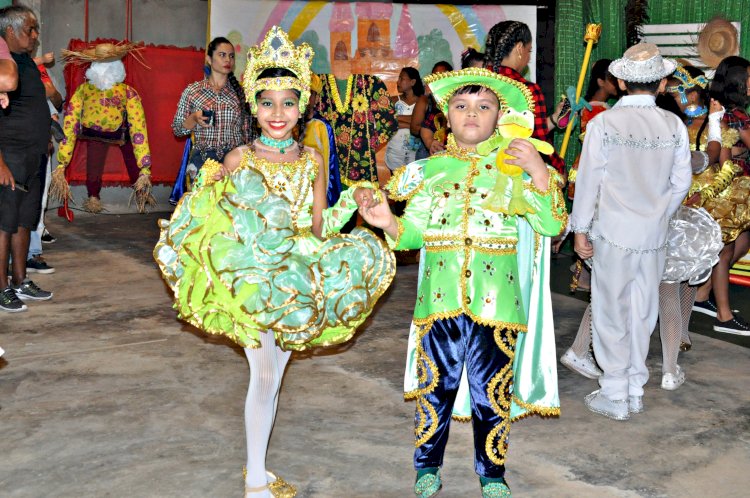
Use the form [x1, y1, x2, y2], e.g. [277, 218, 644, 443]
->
[245, 333, 291, 498]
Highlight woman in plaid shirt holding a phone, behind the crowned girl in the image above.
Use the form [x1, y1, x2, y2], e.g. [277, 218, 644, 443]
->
[169, 36, 252, 204]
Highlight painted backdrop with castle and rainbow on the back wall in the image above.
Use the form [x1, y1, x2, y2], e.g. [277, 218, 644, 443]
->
[209, 0, 536, 94]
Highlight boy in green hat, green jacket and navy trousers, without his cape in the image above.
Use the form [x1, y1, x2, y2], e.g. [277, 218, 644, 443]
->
[360, 68, 567, 498]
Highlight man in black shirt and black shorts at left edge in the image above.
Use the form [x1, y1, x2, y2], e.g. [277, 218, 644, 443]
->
[0, 5, 52, 312]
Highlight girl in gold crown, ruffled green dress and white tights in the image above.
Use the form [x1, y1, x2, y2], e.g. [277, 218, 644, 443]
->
[154, 27, 395, 498]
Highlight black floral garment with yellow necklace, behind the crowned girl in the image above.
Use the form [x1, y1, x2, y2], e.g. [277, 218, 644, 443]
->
[318, 74, 398, 185]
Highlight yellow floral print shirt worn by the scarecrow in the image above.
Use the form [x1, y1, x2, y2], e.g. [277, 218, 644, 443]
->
[57, 82, 151, 174]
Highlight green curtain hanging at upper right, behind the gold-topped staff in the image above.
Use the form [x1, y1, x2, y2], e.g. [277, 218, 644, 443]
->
[555, 0, 750, 165]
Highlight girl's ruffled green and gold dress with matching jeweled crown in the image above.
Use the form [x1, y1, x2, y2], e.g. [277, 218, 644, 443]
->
[154, 29, 395, 350]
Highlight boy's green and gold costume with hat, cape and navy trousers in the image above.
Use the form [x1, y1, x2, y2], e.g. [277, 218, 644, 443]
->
[386, 68, 567, 496]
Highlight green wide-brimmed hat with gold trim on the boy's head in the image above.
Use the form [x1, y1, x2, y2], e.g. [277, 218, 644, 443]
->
[424, 67, 534, 114]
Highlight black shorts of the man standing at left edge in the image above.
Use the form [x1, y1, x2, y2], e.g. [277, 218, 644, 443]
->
[0, 150, 43, 233]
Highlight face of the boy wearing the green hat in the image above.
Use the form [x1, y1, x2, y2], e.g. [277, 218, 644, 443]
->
[448, 89, 500, 149]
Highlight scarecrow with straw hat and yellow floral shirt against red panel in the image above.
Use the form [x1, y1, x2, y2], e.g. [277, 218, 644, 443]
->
[50, 43, 156, 213]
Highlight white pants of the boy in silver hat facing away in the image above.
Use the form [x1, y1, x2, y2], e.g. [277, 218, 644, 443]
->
[591, 240, 666, 400]
